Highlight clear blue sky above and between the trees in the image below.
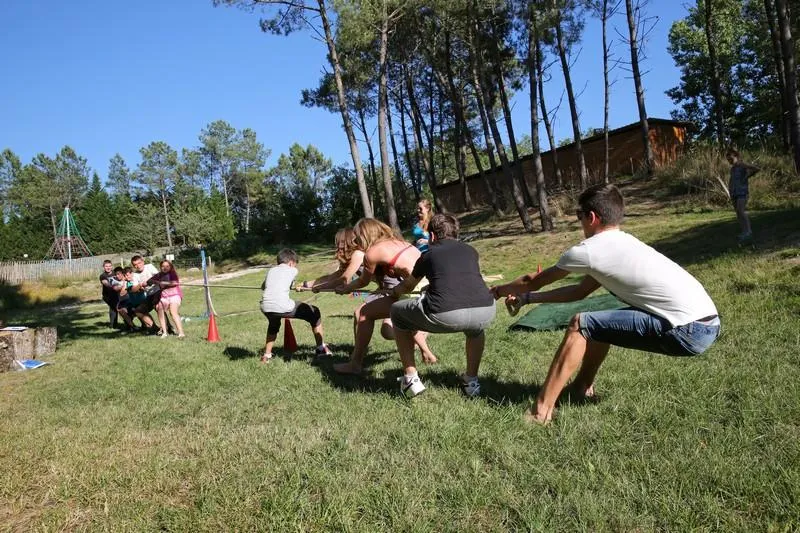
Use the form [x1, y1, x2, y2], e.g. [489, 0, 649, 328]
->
[0, 0, 686, 178]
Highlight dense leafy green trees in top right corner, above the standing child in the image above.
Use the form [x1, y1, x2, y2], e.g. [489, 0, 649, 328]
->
[667, 0, 800, 170]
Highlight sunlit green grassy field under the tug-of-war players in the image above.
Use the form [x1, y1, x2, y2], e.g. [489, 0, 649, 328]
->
[0, 189, 800, 532]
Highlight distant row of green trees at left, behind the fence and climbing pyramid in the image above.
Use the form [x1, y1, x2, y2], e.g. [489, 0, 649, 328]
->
[0, 120, 384, 260]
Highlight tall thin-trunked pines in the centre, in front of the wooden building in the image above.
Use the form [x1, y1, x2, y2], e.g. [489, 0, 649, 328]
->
[214, 0, 676, 231]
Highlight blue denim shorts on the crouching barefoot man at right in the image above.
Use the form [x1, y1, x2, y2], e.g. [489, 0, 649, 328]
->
[579, 307, 720, 356]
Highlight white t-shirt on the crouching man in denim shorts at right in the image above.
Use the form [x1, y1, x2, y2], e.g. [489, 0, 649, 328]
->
[556, 229, 717, 326]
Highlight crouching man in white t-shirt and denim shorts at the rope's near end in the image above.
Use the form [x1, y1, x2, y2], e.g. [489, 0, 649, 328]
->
[492, 185, 720, 423]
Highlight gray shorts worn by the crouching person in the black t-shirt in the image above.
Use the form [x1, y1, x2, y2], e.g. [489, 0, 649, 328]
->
[391, 298, 497, 337]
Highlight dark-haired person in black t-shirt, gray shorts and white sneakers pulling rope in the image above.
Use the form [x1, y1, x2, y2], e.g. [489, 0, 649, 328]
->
[386, 214, 496, 397]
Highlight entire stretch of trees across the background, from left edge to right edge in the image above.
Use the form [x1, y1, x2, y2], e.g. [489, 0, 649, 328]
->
[0, 0, 800, 260]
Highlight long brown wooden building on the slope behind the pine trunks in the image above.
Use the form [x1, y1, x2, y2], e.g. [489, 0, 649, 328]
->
[436, 118, 688, 213]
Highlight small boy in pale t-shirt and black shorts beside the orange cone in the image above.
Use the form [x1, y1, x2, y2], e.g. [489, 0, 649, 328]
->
[261, 248, 333, 362]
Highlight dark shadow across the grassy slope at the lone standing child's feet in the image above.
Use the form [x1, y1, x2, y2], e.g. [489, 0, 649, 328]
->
[650, 208, 800, 266]
